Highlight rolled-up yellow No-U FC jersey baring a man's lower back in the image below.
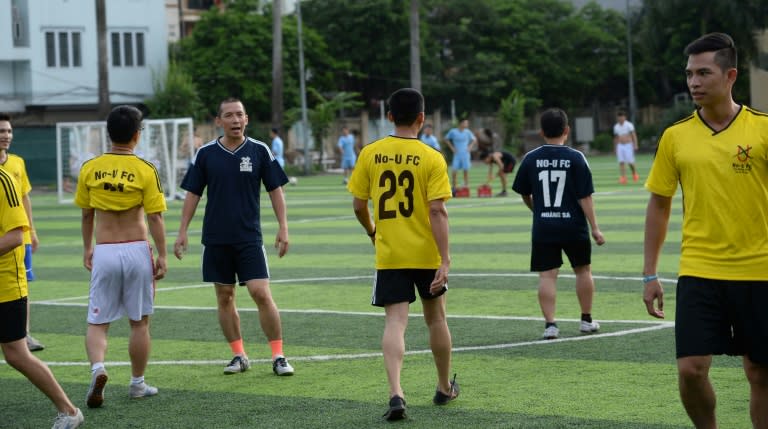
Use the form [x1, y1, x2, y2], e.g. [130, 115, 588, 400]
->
[75, 153, 167, 213]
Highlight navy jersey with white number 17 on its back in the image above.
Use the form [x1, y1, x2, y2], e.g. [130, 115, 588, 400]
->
[512, 145, 595, 243]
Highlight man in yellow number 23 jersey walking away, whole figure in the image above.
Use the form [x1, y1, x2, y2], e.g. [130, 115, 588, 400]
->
[348, 88, 459, 420]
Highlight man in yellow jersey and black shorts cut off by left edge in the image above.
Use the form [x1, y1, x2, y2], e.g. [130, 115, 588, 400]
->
[0, 169, 83, 429]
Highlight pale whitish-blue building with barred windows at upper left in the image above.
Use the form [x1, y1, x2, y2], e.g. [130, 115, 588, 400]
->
[0, 0, 168, 112]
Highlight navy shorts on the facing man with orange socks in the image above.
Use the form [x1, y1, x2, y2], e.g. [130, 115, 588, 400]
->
[203, 243, 269, 286]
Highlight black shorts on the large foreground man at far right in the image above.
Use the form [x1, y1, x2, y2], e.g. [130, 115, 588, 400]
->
[675, 276, 768, 365]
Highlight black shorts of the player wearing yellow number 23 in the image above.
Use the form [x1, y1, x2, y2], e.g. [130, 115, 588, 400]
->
[371, 268, 448, 307]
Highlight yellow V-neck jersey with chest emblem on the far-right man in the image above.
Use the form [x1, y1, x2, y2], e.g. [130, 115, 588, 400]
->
[645, 106, 768, 280]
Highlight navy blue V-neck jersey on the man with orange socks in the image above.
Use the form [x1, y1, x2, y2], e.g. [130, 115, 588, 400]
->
[181, 137, 288, 245]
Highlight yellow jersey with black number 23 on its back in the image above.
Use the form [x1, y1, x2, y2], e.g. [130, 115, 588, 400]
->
[348, 136, 451, 269]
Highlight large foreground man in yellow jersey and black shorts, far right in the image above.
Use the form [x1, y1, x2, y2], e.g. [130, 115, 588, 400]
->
[643, 33, 768, 428]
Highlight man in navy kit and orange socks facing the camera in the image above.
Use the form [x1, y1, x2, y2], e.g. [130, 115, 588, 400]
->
[173, 98, 293, 375]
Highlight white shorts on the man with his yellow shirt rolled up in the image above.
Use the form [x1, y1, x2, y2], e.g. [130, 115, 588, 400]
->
[88, 241, 155, 325]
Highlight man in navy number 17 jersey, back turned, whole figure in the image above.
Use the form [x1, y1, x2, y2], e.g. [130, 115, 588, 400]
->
[512, 109, 605, 339]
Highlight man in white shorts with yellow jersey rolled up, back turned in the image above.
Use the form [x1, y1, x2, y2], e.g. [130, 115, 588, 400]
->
[75, 106, 167, 408]
